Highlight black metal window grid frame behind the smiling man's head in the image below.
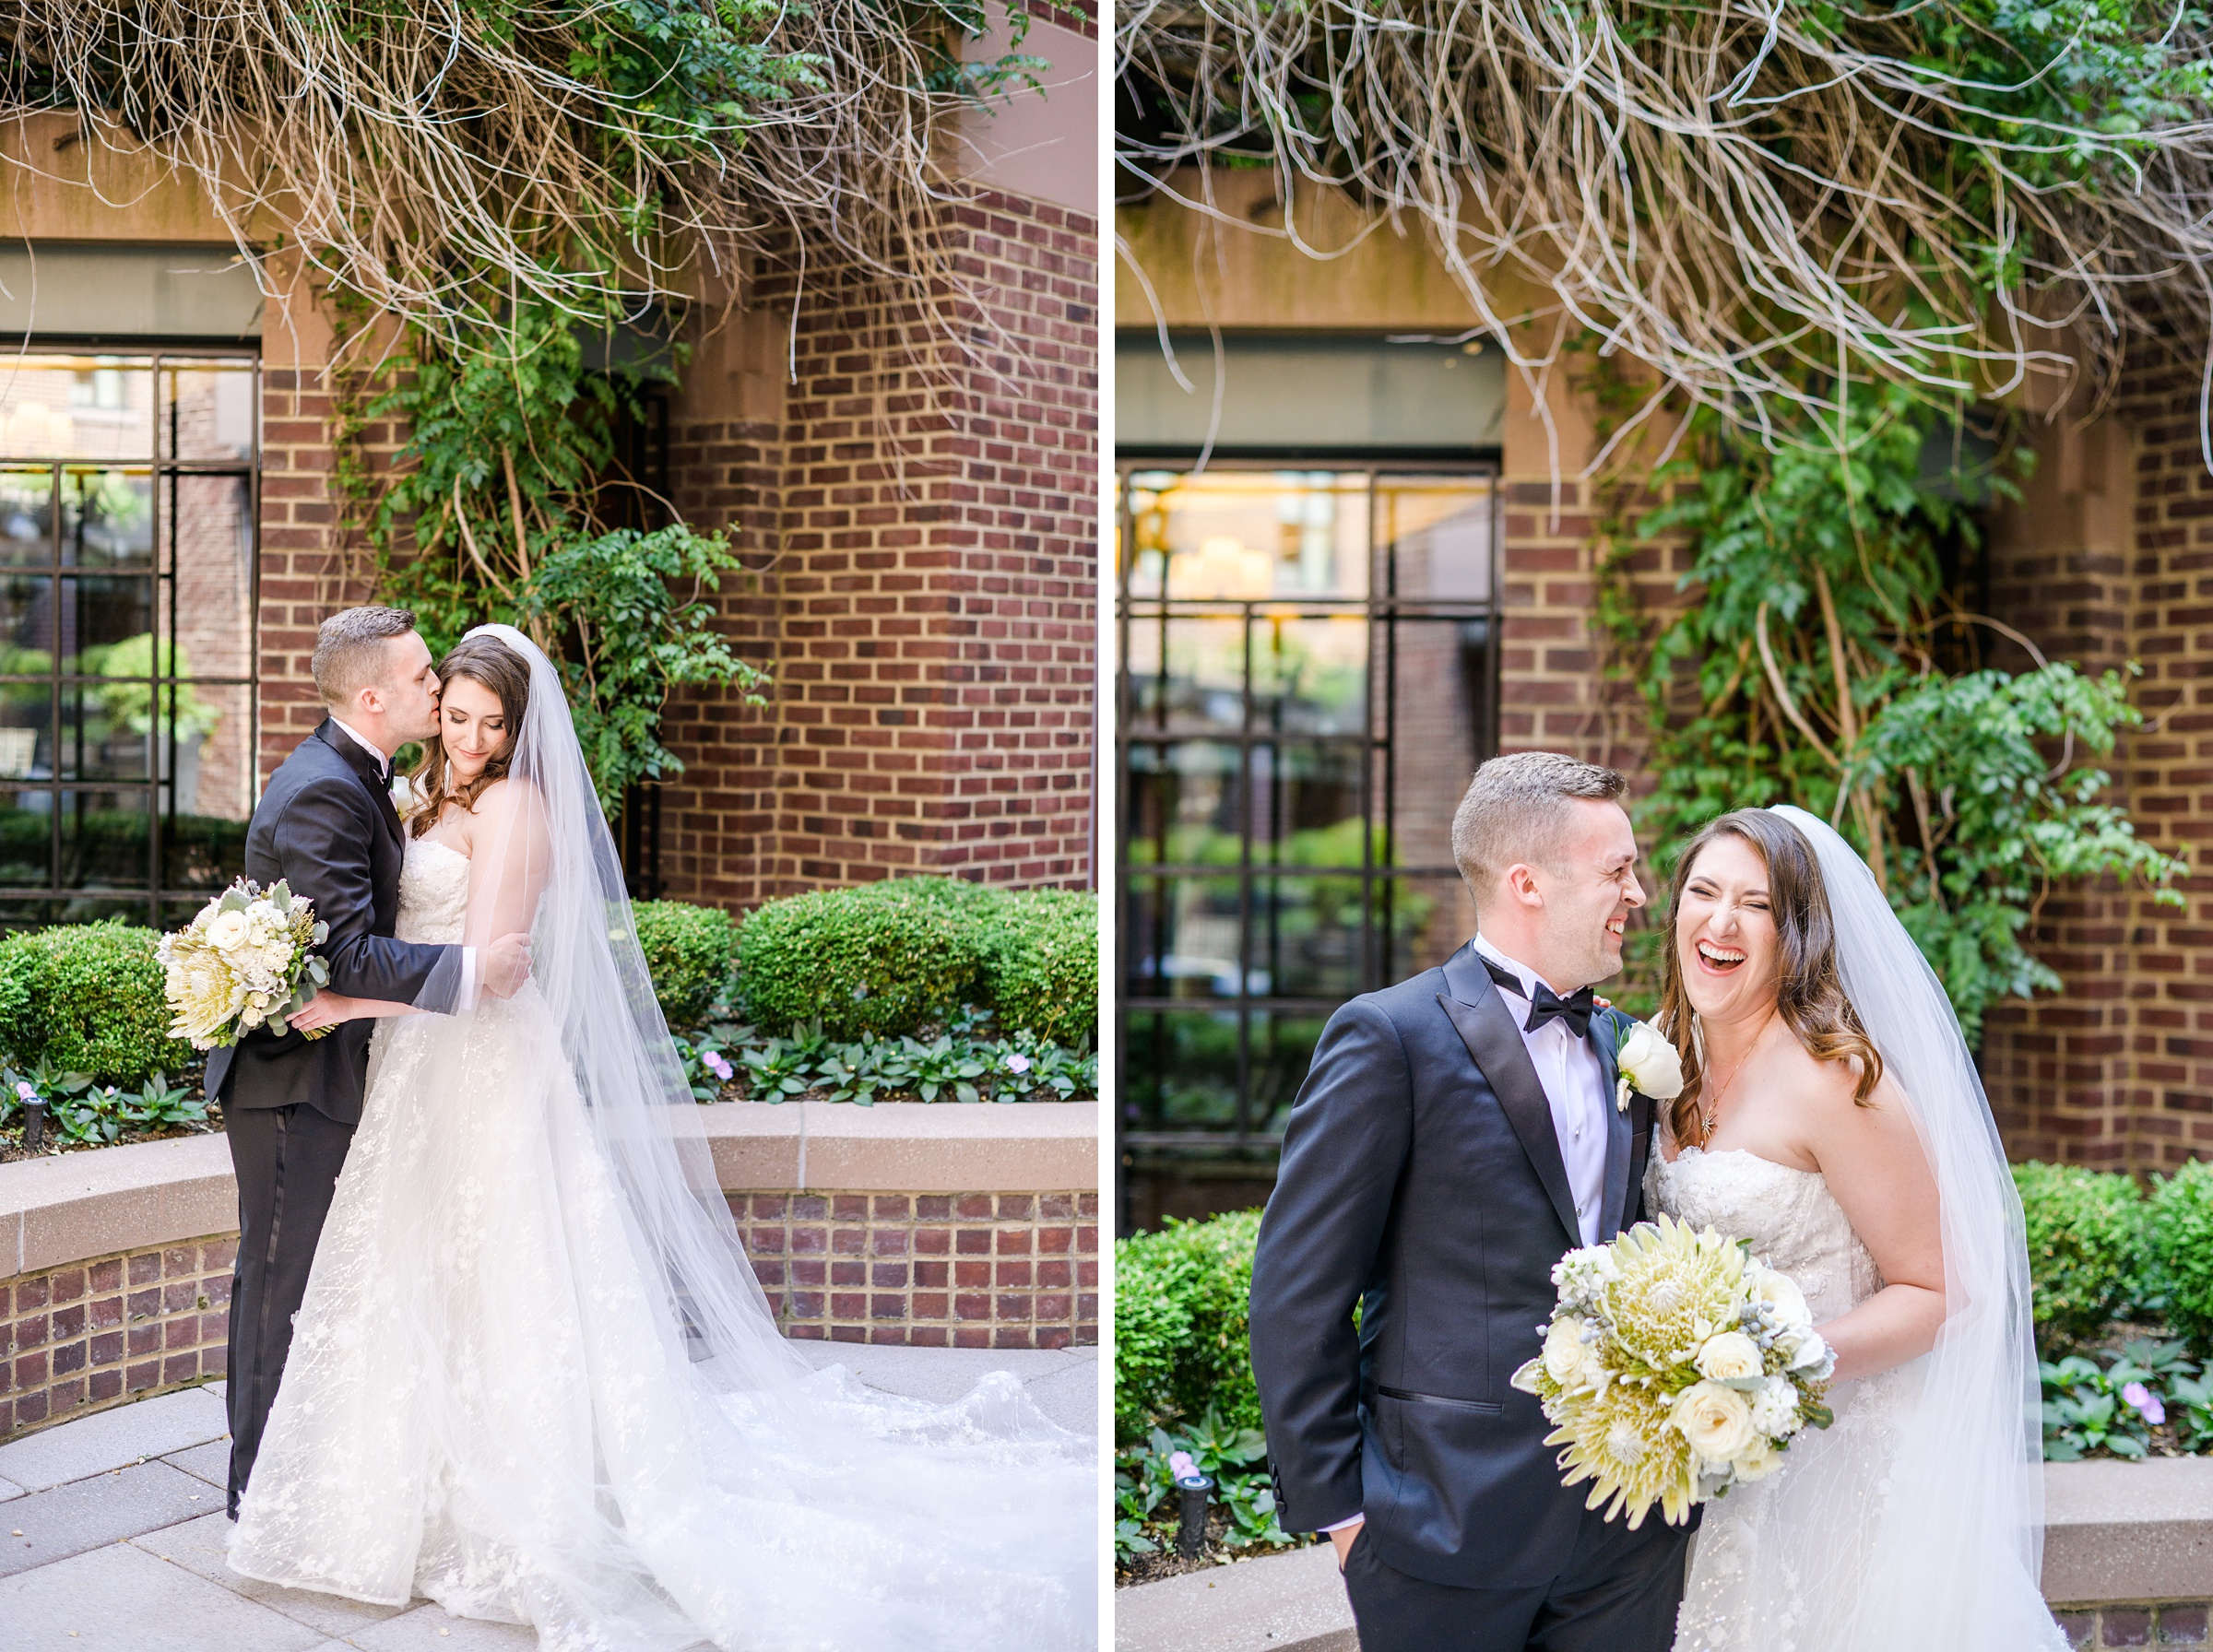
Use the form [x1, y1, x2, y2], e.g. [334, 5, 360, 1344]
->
[1116, 449, 1505, 1157]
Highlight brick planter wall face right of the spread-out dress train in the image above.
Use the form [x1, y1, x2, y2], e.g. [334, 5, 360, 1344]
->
[730, 1192, 1100, 1349]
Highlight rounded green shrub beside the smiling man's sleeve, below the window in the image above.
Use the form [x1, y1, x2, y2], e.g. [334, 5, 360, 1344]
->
[1113, 1210, 1260, 1442]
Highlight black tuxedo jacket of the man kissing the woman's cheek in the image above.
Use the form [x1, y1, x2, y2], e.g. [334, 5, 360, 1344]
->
[208, 716, 460, 1124]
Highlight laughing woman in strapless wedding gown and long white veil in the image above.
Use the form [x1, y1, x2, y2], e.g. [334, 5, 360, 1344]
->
[1647, 808, 2067, 1652]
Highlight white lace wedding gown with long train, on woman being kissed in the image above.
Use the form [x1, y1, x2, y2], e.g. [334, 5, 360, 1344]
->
[231, 838, 1097, 1652]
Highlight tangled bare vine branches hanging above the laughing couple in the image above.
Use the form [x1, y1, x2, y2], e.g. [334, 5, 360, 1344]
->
[1116, 0, 2213, 465]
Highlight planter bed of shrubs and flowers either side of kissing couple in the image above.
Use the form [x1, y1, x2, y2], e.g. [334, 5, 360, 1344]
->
[0, 878, 1097, 1163]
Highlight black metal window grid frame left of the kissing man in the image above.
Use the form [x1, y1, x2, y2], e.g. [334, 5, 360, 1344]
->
[0, 336, 264, 929]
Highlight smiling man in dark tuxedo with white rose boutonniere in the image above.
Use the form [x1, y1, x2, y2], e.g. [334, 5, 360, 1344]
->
[1252, 752, 1688, 1652]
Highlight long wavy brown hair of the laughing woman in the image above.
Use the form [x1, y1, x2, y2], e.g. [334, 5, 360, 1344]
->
[1653, 809, 1883, 1141]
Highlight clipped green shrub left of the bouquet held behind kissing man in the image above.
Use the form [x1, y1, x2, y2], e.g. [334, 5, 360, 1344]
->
[0, 920, 197, 1083]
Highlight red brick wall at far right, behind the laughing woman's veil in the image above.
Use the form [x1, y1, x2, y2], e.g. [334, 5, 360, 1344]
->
[1982, 351, 2213, 1170]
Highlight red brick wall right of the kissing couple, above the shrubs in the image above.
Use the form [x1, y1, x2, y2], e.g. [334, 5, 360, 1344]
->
[662, 195, 1097, 907]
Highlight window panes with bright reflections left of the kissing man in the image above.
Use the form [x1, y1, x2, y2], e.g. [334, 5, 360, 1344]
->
[0, 351, 261, 925]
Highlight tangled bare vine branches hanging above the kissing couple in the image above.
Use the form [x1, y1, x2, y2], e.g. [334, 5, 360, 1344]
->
[0, 0, 1013, 373]
